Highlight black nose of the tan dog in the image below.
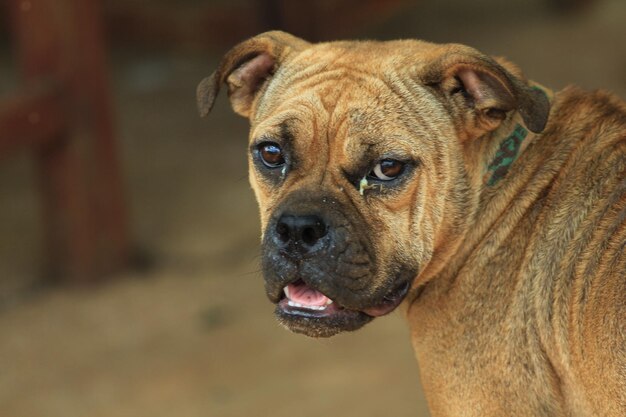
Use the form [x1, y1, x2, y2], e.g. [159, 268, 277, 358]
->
[276, 214, 328, 255]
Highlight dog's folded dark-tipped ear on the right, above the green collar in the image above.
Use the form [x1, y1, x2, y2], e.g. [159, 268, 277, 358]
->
[422, 45, 550, 138]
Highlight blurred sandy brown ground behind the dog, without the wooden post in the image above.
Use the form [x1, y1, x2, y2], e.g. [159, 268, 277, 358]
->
[0, 0, 626, 417]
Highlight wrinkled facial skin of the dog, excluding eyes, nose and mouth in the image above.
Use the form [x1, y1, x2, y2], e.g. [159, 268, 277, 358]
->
[250, 51, 464, 336]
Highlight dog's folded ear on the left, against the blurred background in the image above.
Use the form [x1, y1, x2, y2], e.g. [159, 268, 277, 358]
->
[196, 31, 309, 117]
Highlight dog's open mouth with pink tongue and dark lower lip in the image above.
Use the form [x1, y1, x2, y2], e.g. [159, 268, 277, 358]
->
[276, 280, 409, 337]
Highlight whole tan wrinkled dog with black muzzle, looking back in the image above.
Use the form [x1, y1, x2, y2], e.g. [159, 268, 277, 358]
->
[198, 32, 626, 417]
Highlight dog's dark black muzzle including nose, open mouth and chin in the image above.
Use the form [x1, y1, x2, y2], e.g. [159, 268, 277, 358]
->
[263, 197, 411, 337]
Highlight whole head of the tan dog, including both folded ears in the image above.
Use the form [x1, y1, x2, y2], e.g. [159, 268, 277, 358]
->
[198, 32, 547, 336]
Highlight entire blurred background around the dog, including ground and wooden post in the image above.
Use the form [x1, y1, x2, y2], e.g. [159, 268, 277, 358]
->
[0, 0, 626, 417]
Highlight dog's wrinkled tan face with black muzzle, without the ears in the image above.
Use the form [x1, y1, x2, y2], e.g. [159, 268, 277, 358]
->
[250, 51, 434, 336]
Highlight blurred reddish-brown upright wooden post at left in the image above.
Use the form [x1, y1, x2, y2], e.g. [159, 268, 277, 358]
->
[9, 0, 129, 283]
